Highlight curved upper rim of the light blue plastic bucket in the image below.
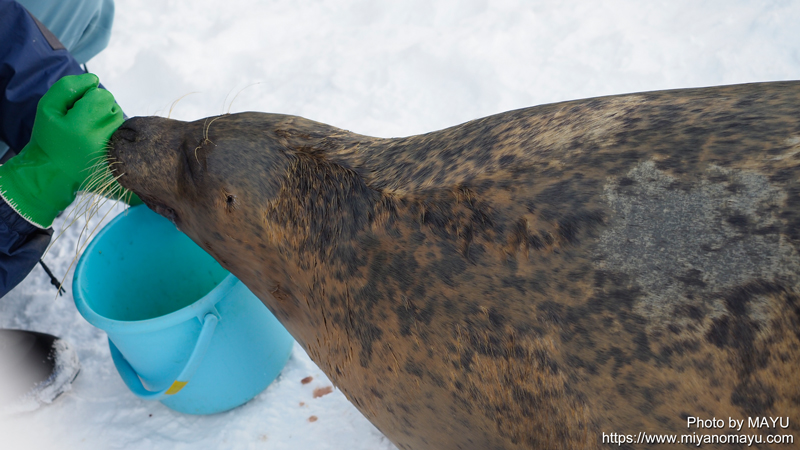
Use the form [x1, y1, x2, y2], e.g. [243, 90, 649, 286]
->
[72, 205, 239, 334]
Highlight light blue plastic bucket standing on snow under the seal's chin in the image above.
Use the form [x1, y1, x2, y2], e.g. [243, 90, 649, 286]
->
[73, 206, 293, 414]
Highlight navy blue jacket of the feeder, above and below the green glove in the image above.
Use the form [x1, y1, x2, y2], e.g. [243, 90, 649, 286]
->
[0, 0, 97, 297]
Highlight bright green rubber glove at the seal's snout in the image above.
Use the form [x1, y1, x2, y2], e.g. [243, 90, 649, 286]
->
[0, 74, 140, 228]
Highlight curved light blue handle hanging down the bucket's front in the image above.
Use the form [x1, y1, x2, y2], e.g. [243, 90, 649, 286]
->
[108, 313, 219, 400]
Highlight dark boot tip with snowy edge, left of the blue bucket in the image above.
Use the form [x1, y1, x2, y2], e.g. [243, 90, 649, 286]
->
[0, 329, 80, 414]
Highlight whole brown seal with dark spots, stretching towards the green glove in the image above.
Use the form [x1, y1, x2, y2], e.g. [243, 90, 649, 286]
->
[109, 82, 800, 450]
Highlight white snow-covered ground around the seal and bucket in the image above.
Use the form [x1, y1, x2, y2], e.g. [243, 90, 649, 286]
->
[0, 0, 800, 450]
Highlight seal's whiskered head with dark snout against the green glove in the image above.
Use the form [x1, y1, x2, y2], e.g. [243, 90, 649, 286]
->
[109, 113, 302, 298]
